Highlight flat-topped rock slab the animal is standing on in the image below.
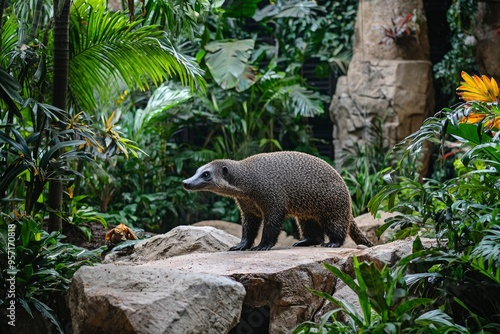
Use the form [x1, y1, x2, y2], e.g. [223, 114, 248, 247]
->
[140, 240, 430, 334]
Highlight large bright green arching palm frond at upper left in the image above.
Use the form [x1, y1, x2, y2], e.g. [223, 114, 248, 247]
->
[69, 1, 205, 108]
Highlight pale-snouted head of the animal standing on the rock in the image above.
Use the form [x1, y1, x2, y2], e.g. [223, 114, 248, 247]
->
[182, 160, 242, 197]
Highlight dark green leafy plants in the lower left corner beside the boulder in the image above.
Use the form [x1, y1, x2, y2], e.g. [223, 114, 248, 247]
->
[0, 214, 103, 333]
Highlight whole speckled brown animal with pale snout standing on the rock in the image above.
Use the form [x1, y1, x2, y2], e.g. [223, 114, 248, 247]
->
[182, 151, 373, 250]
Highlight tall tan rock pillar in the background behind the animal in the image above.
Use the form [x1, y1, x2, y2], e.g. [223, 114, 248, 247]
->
[330, 0, 434, 163]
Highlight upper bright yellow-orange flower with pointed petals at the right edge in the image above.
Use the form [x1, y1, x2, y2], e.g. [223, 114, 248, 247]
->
[457, 71, 500, 102]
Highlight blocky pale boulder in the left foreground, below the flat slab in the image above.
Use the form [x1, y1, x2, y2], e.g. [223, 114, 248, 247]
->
[69, 264, 245, 334]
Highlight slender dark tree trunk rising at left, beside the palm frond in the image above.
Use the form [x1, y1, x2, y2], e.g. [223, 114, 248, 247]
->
[47, 0, 71, 231]
